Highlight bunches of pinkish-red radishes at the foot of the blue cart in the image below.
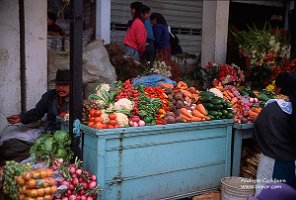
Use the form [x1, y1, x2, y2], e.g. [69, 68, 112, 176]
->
[55, 158, 100, 200]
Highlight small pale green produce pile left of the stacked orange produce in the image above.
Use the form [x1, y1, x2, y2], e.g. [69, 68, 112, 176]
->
[3, 161, 32, 200]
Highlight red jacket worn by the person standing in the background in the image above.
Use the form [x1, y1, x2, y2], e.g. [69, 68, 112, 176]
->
[123, 18, 147, 54]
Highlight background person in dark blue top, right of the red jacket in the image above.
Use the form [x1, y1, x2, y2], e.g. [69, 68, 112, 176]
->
[150, 13, 171, 63]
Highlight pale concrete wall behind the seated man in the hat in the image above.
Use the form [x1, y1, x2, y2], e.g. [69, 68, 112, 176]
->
[0, 0, 47, 134]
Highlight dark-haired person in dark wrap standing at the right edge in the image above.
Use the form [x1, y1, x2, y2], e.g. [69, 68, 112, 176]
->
[254, 72, 296, 194]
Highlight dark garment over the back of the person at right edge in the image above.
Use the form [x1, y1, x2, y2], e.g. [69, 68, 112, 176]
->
[254, 102, 296, 161]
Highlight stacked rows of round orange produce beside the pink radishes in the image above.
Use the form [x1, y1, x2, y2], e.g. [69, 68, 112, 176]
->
[16, 168, 57, 200]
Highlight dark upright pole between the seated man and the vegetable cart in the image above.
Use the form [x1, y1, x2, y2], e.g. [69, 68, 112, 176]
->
[69, 0, 83, 159]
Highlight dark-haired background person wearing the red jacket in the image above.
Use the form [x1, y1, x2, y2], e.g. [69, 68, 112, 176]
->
[123, 2, 147, 61]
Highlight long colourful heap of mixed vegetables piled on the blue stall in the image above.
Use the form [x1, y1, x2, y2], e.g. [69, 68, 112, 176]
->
[83, 80, 275, 129]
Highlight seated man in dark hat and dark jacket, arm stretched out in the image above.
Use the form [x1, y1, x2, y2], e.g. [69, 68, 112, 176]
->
[0, 70, 71, 161]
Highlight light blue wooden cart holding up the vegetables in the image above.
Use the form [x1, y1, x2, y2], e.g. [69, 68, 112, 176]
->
[75, 120, 233, 200]
